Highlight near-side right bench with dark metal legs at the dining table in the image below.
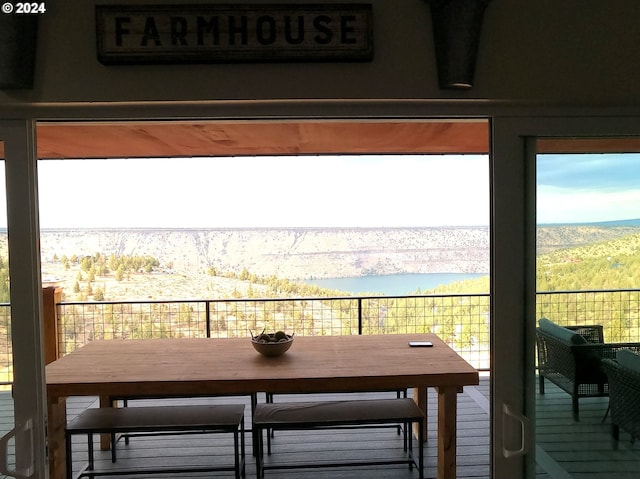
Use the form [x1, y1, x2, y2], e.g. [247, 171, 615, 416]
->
[253, 398, 425, 479]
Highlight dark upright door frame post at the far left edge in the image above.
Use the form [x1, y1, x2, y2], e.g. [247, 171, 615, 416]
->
[0, 120, 48, 477]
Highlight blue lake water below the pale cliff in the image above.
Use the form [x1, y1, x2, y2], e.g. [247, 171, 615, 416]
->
[304, 273, 487, 296]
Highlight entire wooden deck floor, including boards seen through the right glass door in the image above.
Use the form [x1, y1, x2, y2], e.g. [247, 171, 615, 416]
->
[0, 378, 640, 479]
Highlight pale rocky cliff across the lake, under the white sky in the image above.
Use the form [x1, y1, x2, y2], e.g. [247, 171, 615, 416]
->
[41, 227, 489, 279]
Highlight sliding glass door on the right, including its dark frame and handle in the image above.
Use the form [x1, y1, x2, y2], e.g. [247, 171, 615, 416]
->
[492, 118, 640, 479]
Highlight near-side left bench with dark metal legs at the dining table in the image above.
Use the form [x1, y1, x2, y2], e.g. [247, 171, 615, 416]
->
[65, 404, 245, 479]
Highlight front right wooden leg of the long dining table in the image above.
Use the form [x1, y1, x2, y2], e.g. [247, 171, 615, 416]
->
[437, 386, 458, 479]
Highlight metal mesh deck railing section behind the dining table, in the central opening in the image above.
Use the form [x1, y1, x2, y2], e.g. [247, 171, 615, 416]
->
[58, 294, 489, 368]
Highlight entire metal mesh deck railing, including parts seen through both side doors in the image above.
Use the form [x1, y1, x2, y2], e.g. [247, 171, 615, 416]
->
[0, 289, 640, 385]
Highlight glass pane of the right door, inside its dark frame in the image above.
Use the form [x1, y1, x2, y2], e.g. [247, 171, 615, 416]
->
[531, 141, 640, 479]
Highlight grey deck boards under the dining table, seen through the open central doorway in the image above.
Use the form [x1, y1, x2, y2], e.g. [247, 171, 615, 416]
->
[62, 384, 489, 479]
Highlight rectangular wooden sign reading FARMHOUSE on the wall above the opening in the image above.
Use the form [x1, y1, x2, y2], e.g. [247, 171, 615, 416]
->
[96, 4, 373, 65]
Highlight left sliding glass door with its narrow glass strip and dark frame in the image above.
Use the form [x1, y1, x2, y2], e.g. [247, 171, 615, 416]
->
[0, 121, 48, 478]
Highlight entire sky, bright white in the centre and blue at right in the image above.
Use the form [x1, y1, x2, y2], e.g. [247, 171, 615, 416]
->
[0, 154, 640, 228]
